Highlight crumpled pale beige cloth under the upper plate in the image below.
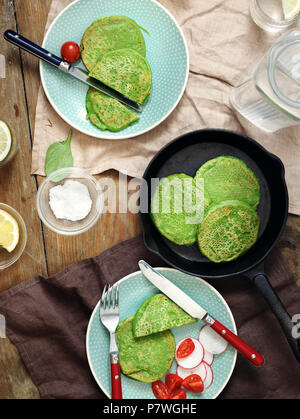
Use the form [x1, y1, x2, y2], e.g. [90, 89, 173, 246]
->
[32, 0, 300, 215]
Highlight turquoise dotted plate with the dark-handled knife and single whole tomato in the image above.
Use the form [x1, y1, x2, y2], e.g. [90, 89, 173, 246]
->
[40, 0, 189, 140]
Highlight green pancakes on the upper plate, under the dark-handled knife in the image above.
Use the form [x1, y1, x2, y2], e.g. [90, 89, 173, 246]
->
[81, 16, 152, 132]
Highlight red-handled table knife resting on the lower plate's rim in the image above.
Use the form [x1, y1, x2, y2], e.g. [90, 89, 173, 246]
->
[139, 260, 264, 366]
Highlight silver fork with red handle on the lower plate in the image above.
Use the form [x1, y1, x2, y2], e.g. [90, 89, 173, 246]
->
[100, 285, 122, 399]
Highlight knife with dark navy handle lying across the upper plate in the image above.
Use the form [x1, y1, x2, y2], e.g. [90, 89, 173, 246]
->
[4, 29, 143, 113]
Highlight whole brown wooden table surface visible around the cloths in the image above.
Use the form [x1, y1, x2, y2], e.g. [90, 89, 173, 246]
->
[0, 0, 300, 399]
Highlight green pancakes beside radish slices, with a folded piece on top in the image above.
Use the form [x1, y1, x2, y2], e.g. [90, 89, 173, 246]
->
[116, 294, 197, 383]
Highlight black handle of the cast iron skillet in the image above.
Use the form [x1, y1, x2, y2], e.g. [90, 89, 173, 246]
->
[253, 273, 300, 363]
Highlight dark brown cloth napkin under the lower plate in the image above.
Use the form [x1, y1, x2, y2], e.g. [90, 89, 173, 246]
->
[0, 236, 300, 399]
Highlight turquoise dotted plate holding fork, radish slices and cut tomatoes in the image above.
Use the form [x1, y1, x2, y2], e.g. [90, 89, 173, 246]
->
[86, 268, 237, 399]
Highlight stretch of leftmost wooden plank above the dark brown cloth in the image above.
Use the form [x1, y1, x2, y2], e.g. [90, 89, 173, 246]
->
[0, 0, 46, 291]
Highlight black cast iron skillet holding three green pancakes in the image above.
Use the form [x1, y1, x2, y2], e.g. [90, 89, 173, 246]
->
[140, 129, 300, 362]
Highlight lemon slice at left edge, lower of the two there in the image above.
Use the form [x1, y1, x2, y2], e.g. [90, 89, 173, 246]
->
[0, 210, 19, 253]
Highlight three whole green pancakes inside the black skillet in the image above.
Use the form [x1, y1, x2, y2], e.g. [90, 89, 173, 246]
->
[151, 156, 260, 263]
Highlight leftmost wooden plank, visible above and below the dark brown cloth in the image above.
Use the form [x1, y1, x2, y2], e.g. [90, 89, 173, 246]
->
[0, 0, 47, 398]
